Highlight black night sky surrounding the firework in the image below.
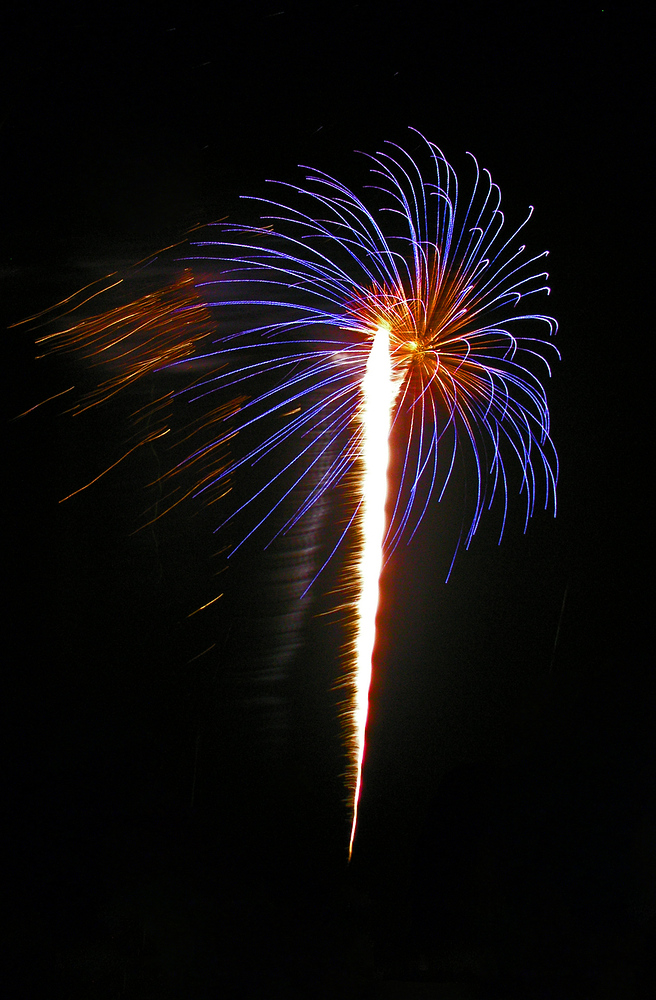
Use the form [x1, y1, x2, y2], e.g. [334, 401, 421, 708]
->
[5, 2, 656, 1000]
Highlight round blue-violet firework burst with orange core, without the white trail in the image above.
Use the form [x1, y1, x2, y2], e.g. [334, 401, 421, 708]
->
[186, 131, 557, 580]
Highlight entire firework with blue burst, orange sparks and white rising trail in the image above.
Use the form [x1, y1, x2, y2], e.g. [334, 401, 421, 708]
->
[21, 133, 558, 856]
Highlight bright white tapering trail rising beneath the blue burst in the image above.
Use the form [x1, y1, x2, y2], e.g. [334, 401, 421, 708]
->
[349, 326, 399, 859]
